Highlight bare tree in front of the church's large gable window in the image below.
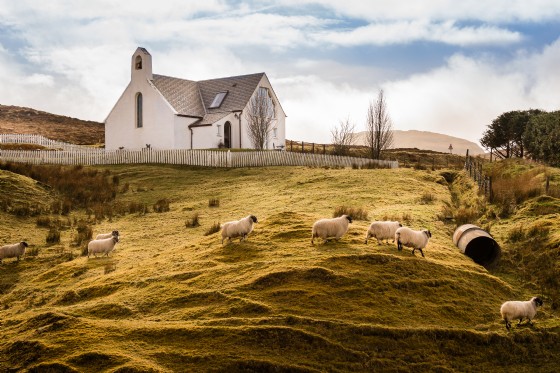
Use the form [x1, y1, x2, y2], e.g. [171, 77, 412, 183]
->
[245, 87, 276, 150]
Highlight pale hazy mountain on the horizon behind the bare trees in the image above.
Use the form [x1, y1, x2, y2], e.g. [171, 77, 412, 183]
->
[356, 130, 484, 155]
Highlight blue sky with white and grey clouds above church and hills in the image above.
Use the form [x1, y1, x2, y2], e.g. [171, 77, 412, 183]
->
[0, 0, 560, 147]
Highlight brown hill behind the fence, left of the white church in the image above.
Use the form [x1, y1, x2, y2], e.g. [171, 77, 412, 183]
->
[0, 105, 105, 145]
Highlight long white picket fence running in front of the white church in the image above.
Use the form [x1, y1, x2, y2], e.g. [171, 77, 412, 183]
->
[0, 135, 399, 168]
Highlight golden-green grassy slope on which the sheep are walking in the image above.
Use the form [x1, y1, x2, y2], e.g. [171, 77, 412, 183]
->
[0, 165, 560, 372]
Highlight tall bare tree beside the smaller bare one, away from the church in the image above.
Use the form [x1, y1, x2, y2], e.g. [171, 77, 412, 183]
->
[366, 90, 393, 159]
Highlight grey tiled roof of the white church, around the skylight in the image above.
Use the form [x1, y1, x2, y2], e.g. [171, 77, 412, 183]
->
[152, 73, 264, 124]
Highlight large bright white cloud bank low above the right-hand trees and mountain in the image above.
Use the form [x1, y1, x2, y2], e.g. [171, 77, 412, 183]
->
[383, 41, 560, 142]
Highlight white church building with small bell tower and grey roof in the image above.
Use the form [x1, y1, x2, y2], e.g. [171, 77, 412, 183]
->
[105, 48, 286, 150]
